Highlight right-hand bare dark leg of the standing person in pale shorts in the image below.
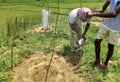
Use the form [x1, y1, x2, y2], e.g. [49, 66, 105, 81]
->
[102, 43, 114, 69]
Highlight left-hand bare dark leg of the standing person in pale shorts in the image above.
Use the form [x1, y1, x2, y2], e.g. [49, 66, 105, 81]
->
[94, 39, 102, 65]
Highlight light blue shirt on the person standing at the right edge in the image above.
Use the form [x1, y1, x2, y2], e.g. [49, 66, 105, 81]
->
[103, 0, 120, 32]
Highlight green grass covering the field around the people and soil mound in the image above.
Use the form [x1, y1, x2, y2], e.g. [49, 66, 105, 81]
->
[0, 0, 120, 82]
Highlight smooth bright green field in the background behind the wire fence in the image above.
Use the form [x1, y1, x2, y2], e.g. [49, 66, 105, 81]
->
[0, 2, 101, 36]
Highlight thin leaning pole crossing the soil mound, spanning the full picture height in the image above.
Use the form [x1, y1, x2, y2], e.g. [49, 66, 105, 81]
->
[45, 0, 60, 82]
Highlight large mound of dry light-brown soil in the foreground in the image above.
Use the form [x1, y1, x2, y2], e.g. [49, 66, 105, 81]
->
[11, 51, 84, 82]
